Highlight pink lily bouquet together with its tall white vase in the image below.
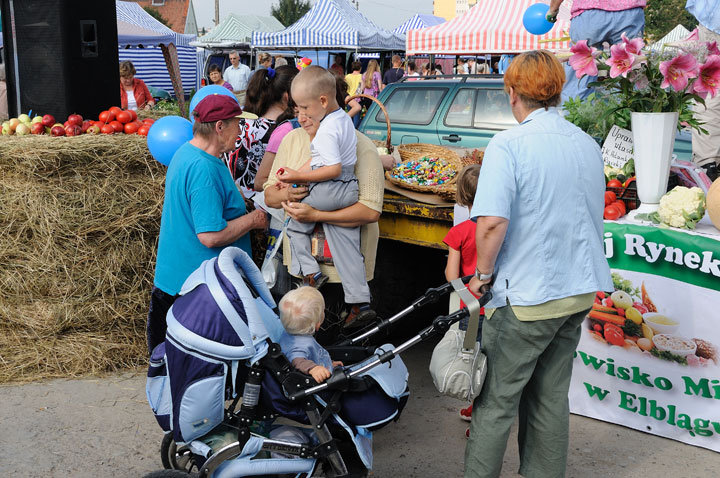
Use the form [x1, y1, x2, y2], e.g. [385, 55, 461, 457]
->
[568, 34, 720, 213]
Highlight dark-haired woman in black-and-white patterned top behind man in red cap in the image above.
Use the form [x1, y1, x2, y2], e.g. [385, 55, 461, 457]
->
[223, 65, 298, 189]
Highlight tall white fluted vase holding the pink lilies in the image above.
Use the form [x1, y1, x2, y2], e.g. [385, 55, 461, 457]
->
[630, 112, 678, 214]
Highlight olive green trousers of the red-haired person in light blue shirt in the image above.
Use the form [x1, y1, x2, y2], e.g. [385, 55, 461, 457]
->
[465, 306, 588, 478]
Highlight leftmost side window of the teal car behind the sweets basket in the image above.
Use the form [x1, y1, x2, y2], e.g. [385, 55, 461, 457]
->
[375, 87, 448, 125]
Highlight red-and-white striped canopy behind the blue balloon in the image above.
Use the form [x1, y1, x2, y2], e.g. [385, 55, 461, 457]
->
[406, 0, 570, 55]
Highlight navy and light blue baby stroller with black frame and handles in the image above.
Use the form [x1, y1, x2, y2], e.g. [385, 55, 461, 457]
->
[146, 247, 489, 478]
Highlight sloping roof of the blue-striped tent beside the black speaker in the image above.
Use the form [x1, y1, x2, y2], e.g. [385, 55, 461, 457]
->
[115, 2, 195, 47]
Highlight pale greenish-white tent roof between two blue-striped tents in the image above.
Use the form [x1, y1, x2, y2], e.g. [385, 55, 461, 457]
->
[193, 13, 285, 48]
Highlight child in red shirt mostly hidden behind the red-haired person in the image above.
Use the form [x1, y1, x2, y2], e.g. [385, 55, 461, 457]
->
[443, 164, 485, 430]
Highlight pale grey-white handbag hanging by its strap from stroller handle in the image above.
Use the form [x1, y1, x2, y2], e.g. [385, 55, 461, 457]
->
[430, 279, 487, 401]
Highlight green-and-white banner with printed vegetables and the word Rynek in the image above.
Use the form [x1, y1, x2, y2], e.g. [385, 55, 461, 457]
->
[569, 223, 720, 451]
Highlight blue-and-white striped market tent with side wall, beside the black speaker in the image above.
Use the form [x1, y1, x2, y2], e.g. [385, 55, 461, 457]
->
[116, 1, 199, 93]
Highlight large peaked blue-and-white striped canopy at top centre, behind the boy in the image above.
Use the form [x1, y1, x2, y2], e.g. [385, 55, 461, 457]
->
[252, 0, 405, 51]
